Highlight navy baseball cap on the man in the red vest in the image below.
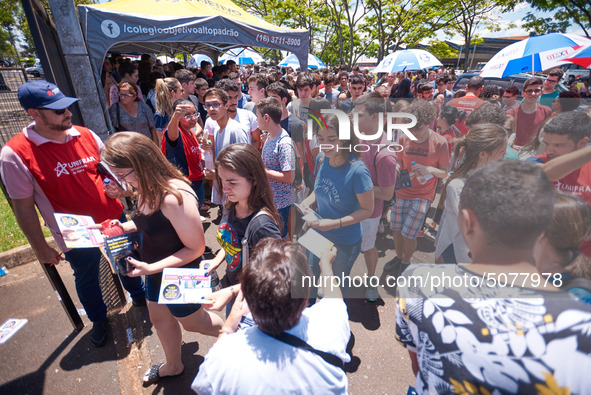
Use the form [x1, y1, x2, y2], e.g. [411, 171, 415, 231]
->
[18, 80, 80, 110]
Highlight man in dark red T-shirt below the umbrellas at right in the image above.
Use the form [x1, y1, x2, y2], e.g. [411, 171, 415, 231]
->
[507, 77, 552, 147]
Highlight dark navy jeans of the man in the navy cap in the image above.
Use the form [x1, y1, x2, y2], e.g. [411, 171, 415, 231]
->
[65, 248, 145, 322]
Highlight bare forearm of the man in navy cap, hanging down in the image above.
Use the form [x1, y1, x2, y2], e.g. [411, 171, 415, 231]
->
[12, 196, 60, 264]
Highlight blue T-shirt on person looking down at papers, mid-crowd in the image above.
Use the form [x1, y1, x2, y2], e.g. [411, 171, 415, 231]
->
[314, 153, 373, 245]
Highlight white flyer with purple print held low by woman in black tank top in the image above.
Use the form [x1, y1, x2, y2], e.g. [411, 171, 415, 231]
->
[158, 267, 211, 304]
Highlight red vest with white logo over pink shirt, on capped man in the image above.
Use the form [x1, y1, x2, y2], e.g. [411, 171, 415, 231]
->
[0, 124, 123, 248]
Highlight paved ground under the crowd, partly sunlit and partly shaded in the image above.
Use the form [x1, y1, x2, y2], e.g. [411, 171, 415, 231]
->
[0, 209, 433, 395]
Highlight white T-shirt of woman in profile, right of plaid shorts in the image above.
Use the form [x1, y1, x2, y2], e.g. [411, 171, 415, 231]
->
[435, 178, 472, 263]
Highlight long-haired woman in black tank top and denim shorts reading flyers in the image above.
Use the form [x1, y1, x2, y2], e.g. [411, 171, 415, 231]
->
[101, 132, 223, 386]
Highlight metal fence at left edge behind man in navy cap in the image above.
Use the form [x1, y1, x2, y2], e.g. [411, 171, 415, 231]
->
[0, 68, 31, 146]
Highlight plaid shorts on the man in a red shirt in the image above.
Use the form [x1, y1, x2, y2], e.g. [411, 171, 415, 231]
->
[390, 199, 431, 240]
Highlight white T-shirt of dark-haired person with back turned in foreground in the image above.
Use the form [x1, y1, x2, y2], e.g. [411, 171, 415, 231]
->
[191, 298, 351, 395]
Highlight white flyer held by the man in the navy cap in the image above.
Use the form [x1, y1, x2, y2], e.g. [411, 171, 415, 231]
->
[53, 213, 103, 248]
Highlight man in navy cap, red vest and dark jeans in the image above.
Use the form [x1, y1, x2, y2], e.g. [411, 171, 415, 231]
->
[0, 80, 146, 347]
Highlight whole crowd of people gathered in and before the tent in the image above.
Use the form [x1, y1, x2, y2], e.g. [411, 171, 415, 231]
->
[0, 51, 591, 394]
